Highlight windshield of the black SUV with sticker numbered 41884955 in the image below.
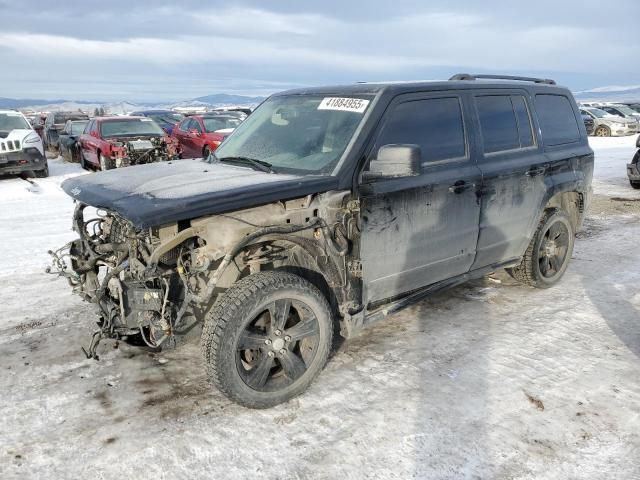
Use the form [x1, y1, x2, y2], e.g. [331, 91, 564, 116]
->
[216, 95, 371, 174]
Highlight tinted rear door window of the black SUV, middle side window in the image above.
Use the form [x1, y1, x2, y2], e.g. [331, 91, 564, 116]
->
[476, 95, 534, 153]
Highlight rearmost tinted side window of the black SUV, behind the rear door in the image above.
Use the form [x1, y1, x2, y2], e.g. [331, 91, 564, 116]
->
[536, 95, 580, 146]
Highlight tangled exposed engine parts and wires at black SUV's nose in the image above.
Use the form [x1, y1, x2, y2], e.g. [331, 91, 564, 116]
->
[50, 203, 195, 359]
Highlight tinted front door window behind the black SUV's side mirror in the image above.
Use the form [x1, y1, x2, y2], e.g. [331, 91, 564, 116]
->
[377, 98, 466, 162]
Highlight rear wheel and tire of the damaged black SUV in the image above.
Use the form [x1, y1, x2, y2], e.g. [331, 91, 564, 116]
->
[507, 209, 575, 288]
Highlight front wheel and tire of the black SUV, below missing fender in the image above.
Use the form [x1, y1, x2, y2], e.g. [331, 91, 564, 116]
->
[202, 271, 333, 408]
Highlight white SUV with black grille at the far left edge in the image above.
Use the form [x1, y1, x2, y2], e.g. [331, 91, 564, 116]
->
[0, 110, 49, 177]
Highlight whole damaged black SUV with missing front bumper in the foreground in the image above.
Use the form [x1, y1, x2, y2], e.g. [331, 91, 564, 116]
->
[52, 74, 594, 408]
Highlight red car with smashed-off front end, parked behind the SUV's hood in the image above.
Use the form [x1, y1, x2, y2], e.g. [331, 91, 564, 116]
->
[78, 117, 180, 170]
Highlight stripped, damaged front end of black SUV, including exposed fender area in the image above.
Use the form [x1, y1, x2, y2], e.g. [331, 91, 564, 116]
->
[48, 194, 362, 359]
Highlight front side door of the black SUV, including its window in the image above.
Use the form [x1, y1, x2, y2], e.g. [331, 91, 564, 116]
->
[360, 92, 481, 303]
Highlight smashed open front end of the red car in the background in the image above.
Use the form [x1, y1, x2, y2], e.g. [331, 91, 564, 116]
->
[109, 136, 180, 168]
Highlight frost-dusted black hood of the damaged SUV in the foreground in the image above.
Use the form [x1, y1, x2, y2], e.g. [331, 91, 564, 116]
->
[62, 159, 338, 228]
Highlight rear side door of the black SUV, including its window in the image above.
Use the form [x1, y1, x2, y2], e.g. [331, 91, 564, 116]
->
[472, 90, 550, 269]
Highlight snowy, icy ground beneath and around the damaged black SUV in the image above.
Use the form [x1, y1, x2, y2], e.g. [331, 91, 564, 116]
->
[0, 137, 640, 480]
